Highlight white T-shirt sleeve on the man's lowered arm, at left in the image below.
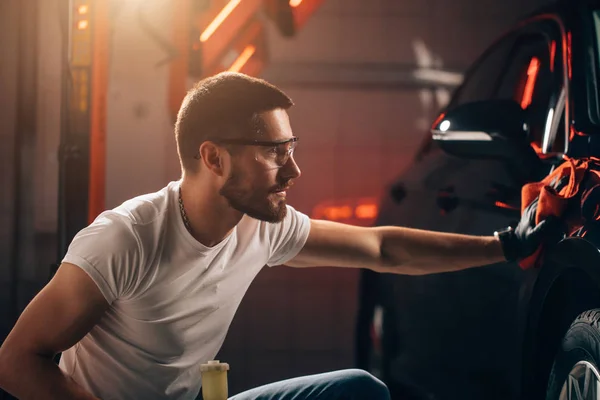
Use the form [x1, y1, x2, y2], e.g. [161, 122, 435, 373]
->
[62, 214, 142, 303]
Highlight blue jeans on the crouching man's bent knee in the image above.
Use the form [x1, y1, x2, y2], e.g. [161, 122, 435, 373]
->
[230, 369, 390, 400]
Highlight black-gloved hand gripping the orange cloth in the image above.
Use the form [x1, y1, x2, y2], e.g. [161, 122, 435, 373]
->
[494, 177, 569, 261]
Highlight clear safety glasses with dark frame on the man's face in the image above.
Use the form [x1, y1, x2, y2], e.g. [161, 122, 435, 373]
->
[194, 136, 298, 169]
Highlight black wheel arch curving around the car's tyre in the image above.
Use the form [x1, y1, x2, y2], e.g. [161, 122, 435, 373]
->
[521, 238, 600, 400]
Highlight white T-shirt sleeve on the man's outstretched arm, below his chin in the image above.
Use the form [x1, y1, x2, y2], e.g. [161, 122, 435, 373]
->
[267, 206, 310, 267]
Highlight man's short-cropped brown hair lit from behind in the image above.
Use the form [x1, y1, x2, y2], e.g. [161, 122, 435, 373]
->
[175, 72, 294, 172]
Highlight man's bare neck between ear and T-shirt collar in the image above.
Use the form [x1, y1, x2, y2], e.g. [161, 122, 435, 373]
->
[181, 176, 243, 247]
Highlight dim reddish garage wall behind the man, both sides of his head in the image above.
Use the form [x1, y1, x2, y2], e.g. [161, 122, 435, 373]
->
[0, 0, 542, 392]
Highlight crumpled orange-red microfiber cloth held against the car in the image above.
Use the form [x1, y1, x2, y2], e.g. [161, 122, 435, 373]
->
[519, 158, 600, 269]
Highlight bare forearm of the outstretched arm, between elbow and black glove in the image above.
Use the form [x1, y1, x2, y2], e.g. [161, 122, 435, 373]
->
[377, 227, 505, 275]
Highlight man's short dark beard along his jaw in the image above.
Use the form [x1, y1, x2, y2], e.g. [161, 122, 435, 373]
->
[219, 169, 289, 223]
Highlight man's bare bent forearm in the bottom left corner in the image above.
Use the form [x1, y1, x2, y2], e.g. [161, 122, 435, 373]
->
[0, 355, 98, 400]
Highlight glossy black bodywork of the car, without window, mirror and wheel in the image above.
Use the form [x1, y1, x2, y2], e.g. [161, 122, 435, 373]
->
[376, 1, 600, 400]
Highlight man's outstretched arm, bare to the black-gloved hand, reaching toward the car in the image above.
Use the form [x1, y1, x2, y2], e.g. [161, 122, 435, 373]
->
[286, 197, 562, 275]
